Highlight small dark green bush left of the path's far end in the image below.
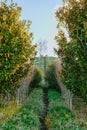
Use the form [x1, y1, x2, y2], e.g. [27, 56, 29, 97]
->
[30, 66, 42, 88]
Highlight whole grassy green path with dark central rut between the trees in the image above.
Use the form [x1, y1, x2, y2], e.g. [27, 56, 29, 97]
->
[0, 88, 86, 130]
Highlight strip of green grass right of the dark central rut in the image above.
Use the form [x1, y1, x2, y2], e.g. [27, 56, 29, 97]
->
[45, 90, 83, 130]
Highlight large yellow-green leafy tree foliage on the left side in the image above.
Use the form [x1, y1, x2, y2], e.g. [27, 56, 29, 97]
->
[0, 2, 36, 94]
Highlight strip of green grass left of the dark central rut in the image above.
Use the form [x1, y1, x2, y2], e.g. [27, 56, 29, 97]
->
[0, 89, 43, 130]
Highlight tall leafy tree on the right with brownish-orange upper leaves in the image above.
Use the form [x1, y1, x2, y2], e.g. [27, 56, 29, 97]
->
[55, 0, 87, 99]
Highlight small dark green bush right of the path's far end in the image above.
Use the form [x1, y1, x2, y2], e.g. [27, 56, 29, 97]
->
[45, 62, 60, 92]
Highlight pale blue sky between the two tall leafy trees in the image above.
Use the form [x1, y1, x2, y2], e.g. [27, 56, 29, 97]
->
[5, 0, 62, 56]
